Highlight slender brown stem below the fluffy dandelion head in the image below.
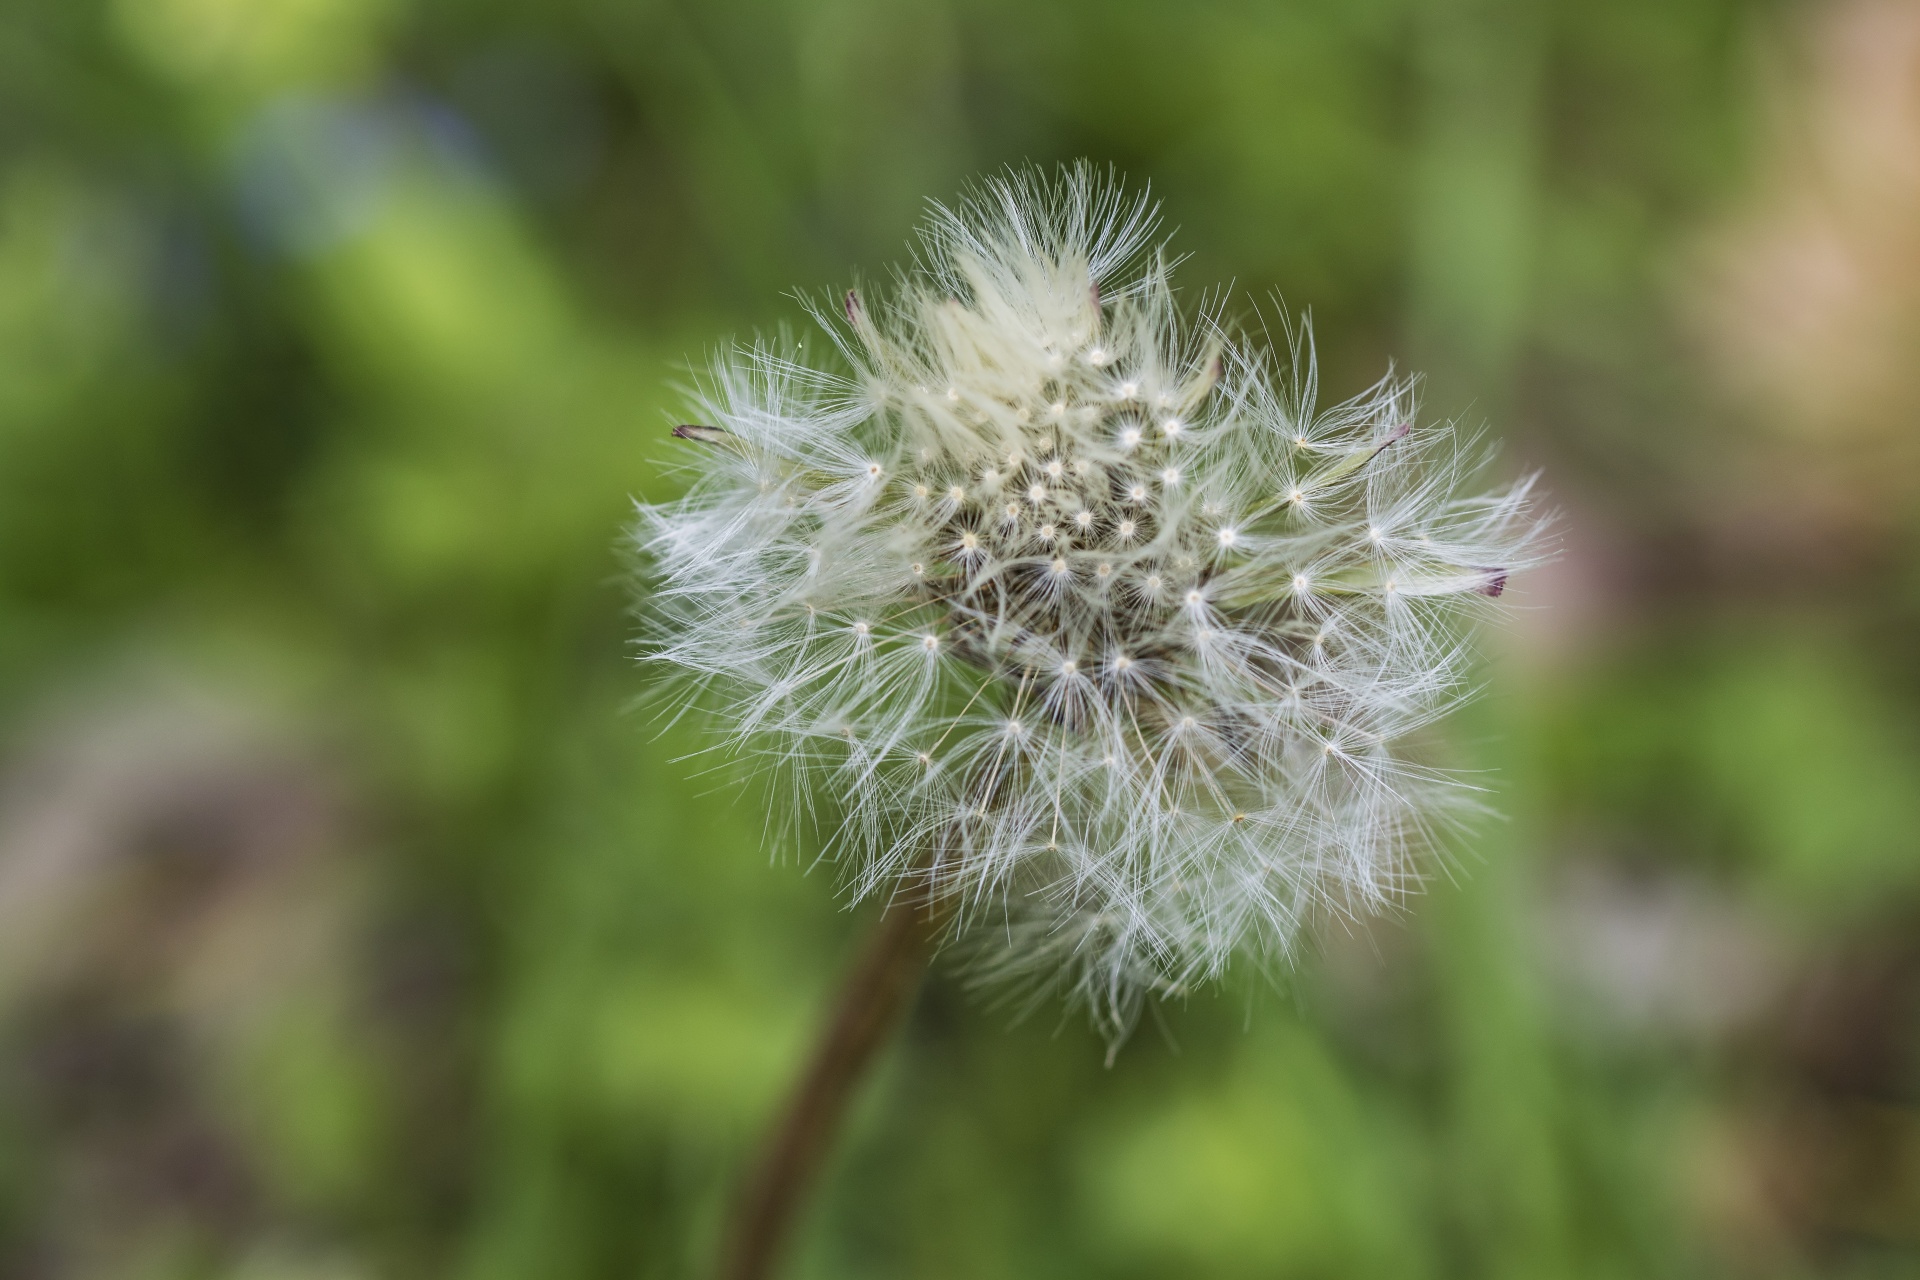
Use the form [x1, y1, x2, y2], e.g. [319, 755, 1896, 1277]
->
[720, 902, 927, 1280]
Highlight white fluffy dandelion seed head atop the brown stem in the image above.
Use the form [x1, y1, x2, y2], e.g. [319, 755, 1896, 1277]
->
[637, 169, 1540, 1036]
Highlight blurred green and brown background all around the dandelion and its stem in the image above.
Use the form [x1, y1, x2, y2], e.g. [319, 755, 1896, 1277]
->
[0, 0, 1920, 1280]
